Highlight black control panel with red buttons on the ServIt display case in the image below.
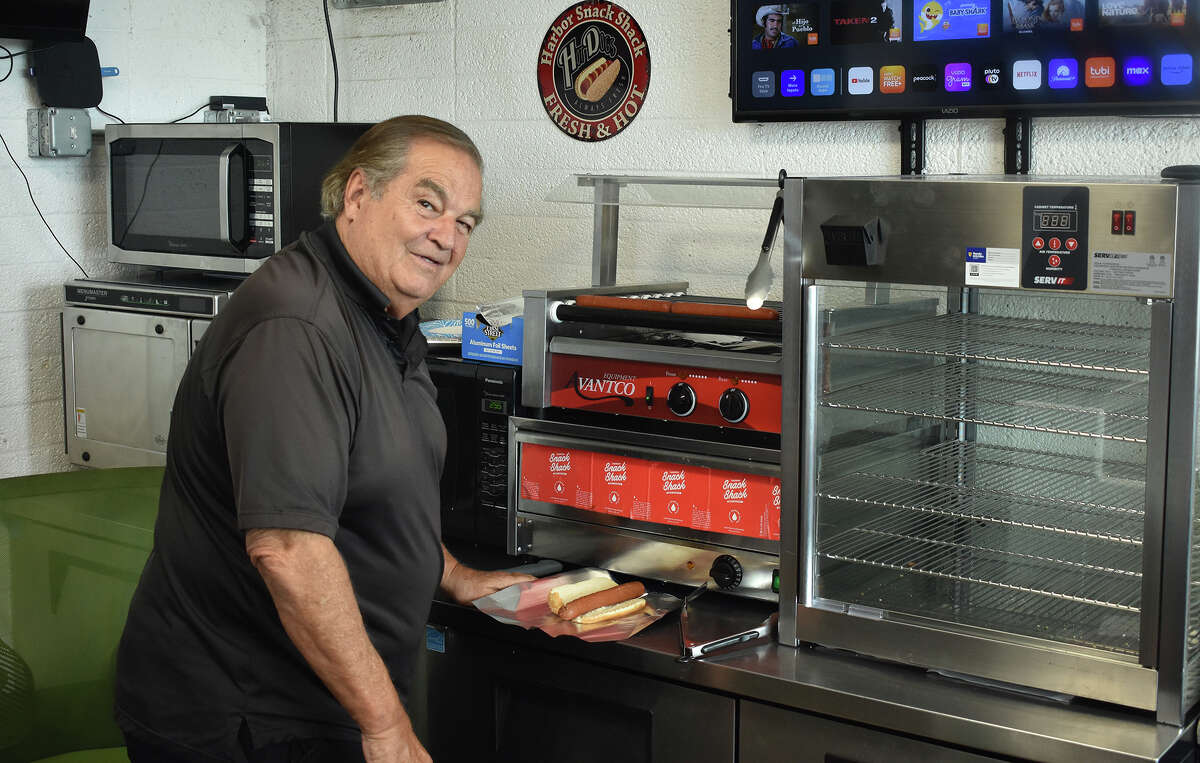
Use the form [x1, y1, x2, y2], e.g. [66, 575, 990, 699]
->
[1021, 186, 1088, 292]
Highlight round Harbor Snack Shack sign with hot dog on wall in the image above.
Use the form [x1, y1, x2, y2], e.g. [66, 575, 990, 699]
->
[538, 2, 650, 140]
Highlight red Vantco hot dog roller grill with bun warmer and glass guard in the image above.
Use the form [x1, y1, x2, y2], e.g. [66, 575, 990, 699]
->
[509, 176, 782, 600]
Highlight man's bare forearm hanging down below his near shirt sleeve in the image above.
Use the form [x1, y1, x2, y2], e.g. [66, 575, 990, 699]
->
[246, 530, 408, 733]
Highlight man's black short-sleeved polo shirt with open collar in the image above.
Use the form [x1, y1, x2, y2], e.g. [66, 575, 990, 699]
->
[116, 224, 445, 759]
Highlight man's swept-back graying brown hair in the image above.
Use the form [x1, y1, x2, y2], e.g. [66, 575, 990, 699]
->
[320, 114, 484, 220]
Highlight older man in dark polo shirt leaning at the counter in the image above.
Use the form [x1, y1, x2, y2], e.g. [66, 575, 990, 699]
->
[116, 116, 528, 763]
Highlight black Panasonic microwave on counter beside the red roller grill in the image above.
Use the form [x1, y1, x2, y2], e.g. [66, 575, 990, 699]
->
[427, 356, 522, 549]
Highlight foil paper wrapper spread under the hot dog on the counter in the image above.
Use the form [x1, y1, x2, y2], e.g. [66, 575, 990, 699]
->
[472, 569, 680, 641]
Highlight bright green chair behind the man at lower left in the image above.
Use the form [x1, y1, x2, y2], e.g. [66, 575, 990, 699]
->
[0, 468, 162, 763]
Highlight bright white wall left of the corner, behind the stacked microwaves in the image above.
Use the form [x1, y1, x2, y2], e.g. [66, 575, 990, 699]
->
[0, 0, 268, 477]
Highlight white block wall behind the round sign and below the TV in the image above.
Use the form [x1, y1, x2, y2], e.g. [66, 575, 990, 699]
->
[266, 0, 1200, 317]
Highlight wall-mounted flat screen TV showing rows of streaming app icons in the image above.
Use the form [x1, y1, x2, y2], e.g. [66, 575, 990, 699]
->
[730, 0, 1200, 121]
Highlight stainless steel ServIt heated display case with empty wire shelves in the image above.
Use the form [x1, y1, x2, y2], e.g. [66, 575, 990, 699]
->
[780, 170, 1200, 723]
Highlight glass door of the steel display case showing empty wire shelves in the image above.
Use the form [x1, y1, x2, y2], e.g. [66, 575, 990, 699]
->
[802, 283, 1157, 661]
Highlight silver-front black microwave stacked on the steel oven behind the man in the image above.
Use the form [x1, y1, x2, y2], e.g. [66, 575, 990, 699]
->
[104, 122, 371, 274]
